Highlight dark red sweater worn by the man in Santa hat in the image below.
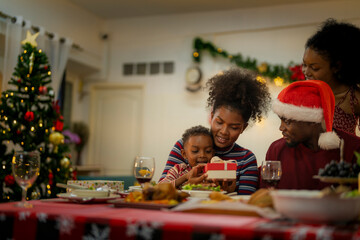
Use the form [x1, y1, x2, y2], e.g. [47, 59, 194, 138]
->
[260, 130, 360, 190]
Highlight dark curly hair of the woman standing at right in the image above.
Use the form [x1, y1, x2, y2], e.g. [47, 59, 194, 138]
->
[305, 18, 360, 86]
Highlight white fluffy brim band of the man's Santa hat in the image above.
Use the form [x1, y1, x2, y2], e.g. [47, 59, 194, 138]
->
[272, 99, 324, 123]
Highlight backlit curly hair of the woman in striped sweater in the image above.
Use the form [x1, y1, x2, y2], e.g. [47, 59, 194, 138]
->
[206, 68, 271, 122]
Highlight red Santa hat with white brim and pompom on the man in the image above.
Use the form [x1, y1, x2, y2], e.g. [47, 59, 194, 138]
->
[272, 80, 340, 149]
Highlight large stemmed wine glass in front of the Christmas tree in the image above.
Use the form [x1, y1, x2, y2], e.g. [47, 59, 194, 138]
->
[12, 151, 40, 208]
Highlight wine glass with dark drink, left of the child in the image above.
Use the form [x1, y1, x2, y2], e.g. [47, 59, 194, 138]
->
[134, 156, 155, 188]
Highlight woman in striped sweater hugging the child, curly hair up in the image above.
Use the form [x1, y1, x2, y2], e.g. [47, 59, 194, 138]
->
[160, 68, 271, 195]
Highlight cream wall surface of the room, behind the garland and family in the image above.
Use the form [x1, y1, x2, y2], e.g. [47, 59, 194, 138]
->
[0, 0, 360, 180]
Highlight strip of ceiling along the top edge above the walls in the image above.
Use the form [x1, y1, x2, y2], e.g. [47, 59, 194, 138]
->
[68, 0, 341, 19]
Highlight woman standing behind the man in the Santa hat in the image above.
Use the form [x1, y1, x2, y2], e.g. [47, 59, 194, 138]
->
[303, 19, 360, 134]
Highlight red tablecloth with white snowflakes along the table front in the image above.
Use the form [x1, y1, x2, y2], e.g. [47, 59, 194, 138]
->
[0, 200, 360, 240]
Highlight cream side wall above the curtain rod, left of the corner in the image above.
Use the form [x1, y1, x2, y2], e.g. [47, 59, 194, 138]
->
[0, 0, 104, 57]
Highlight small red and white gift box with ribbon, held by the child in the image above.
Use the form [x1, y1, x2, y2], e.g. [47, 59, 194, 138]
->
[204, 162, 237, 179]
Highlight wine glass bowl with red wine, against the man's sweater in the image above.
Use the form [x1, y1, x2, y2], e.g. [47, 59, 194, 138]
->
[261, 161, 282, 188]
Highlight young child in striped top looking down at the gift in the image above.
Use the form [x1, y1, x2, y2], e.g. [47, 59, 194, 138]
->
[160, 125, 214, 188]
